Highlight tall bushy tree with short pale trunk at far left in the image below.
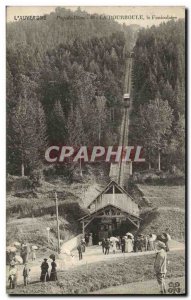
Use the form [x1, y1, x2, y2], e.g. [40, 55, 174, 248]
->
[8, 76, 46, 176]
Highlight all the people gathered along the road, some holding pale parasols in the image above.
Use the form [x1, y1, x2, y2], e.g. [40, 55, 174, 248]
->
[8, 233, 171, 294]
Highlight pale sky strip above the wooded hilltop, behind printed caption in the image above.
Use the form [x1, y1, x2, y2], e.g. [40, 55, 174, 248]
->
[7, 6, 185, 27]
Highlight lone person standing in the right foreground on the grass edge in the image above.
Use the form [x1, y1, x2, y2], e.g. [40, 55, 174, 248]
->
[154, 241, 167, 294]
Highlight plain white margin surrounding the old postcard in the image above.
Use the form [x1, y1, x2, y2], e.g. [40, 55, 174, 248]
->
[0, 0, 191, 299]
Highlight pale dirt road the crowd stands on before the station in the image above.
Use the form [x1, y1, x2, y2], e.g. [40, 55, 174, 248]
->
[7, 240, 184, 284]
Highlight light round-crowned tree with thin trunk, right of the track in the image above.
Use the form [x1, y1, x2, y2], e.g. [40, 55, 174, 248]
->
[139, 99, 173, 171]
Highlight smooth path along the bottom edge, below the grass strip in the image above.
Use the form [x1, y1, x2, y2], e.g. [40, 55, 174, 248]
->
[92, 277, 185, 295]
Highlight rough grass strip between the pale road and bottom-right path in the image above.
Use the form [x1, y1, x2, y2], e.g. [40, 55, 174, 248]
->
[8, 251, 185, 294]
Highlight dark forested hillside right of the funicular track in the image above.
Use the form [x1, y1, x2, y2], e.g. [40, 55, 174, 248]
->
[130, 20, 185, 171]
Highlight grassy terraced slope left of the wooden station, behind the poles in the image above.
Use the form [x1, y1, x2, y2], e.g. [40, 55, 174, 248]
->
[6, 165, 109, 251]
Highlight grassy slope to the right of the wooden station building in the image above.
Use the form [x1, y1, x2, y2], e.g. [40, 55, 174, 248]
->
[139, 185, 185, 241]
